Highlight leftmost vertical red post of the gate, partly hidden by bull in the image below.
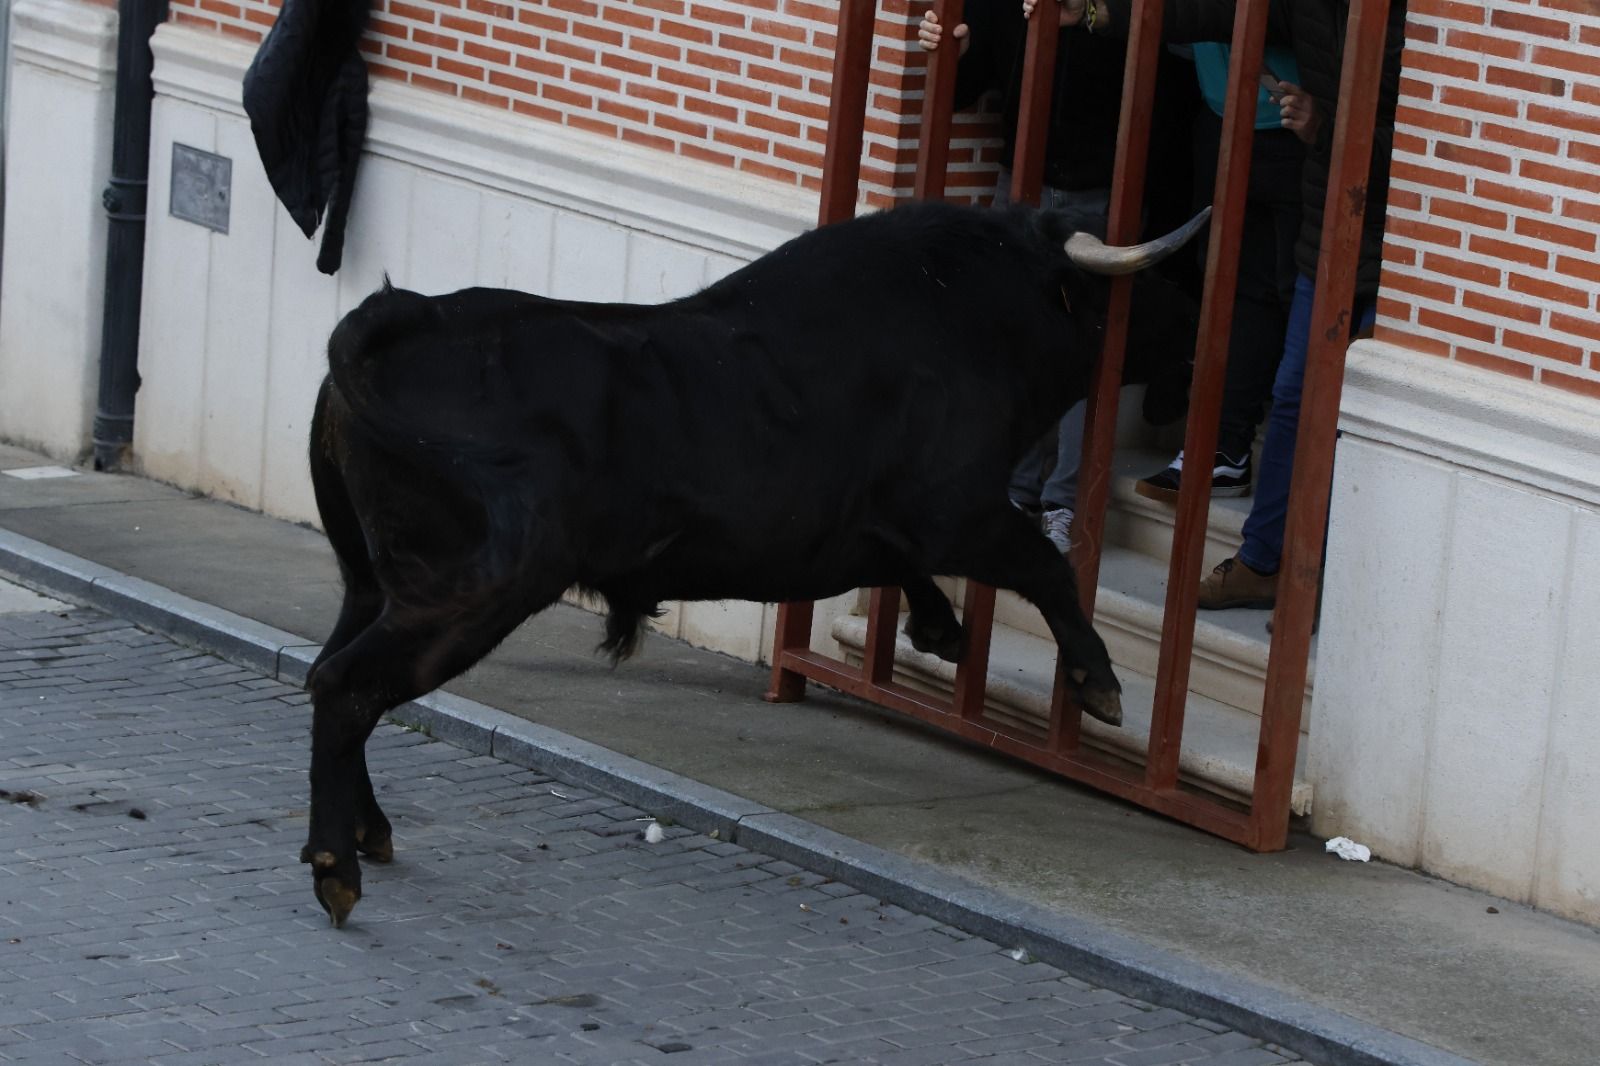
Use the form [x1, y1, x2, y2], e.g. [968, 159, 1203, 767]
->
[766, 0, 877, 703]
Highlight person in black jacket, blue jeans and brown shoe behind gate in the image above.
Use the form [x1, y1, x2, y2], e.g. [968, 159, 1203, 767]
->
[1022, 0, 1406, 610]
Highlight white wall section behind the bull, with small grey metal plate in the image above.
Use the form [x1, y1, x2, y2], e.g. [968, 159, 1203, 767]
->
[134, 26, 854, 661]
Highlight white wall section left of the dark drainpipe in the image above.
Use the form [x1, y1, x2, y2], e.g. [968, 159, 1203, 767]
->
[0, 0, 117, 461]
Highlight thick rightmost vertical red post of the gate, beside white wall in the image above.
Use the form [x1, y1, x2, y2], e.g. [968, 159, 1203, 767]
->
[1250, 0, 1389, 850]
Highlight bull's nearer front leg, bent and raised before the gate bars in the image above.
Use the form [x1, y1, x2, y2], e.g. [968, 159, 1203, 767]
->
[941, 504, 1122, 725]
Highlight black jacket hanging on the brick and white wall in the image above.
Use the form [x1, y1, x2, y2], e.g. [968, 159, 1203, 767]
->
[245, 0, 370, 274]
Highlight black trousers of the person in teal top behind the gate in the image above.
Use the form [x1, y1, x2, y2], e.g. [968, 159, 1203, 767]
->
[1195, 107, 1306, 466]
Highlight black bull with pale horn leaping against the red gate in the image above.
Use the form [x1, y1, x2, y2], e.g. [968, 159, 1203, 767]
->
[301, 205, 1198, 925]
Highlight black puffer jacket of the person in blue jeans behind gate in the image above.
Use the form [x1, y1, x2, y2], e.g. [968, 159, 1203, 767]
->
[1106, 0, 1406, 296]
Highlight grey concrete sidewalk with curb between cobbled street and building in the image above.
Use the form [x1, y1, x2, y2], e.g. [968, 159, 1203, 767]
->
[0, 435, 1600, 1066]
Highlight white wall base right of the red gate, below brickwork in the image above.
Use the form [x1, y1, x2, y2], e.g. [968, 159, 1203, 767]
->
[1310, 343, 1600, 924]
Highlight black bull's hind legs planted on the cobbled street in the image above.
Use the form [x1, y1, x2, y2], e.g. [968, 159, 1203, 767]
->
[301, 589, 555, 927]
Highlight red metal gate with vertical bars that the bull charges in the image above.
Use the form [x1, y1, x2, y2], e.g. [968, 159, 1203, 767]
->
[766, 0, 1389, 852]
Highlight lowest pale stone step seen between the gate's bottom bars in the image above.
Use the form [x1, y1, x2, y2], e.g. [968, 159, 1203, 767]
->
[832, 615, 1312, 815]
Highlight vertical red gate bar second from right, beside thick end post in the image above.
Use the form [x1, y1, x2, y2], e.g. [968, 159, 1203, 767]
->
[1146, 0, 1269, 789]
